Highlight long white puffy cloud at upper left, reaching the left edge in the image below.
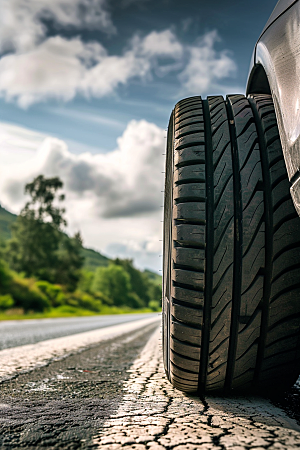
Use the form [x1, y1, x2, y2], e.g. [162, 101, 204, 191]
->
[0, 30, 182, 108]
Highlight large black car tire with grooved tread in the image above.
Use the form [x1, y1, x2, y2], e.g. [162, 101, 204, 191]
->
[163, 95, 300, 392]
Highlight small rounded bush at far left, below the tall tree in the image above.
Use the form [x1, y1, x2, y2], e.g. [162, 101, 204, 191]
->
[9, 276, 51, 312]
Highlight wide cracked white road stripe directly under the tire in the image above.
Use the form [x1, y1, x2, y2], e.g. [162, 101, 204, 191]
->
[93, 330, 300, 450]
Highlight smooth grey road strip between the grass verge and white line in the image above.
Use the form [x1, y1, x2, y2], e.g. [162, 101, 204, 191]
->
[0, 313, 158, 350]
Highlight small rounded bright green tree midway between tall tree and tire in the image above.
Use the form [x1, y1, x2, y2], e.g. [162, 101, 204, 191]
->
[92, 264, 131, 306]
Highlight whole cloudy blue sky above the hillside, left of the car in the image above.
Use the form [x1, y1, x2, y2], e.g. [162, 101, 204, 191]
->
[0, 0, 276, 272]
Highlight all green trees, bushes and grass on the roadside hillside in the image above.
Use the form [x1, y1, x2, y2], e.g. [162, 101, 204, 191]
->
[0, 175, 161, 320]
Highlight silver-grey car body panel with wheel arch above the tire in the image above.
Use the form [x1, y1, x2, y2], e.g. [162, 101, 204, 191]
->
[246, 0, 300, 215]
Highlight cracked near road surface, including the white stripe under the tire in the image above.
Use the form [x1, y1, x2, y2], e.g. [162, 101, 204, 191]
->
[0, 323, 300, 450]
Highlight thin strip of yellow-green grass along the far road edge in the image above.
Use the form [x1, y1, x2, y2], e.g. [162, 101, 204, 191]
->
[0, 305, 160, 321]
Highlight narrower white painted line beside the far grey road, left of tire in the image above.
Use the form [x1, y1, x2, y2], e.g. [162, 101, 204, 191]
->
[0, 317, 161, 381]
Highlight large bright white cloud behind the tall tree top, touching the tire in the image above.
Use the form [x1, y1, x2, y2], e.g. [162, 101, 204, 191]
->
[1, 120, 165, 218]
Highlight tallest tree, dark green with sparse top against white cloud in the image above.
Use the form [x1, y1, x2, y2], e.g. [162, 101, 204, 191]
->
[7, 175, 83, 290]
